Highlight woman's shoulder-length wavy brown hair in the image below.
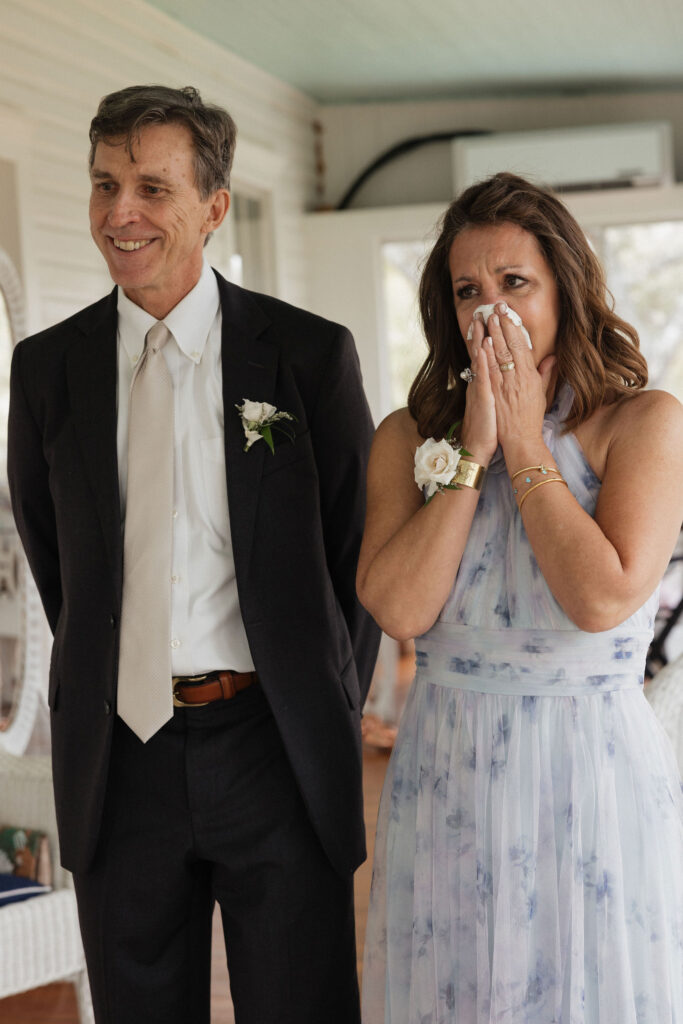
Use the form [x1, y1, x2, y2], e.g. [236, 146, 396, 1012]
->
[408, 173, 647, 437]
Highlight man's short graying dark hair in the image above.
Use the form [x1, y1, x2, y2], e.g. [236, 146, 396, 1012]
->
[89, 85, 238, 200]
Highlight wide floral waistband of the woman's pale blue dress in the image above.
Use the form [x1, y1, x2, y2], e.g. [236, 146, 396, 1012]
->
[415, 622, 651, 696]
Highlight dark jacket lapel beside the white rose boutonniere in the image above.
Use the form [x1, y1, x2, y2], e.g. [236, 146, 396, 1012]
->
[216, 274, 279, 580]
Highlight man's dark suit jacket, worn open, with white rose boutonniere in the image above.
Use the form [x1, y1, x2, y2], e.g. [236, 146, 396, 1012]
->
[8, 275, 379, 872]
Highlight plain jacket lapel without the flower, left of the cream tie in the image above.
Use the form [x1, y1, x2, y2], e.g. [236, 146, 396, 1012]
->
[67, 289, 123, 593]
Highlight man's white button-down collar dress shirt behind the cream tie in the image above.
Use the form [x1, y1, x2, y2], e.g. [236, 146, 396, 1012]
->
[117, 260, 254, 676]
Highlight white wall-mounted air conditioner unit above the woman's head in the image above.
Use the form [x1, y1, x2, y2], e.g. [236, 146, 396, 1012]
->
[453, 121, 674, 196]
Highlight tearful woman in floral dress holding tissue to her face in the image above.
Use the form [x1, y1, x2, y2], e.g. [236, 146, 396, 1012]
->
[357, 174, 683, 1024]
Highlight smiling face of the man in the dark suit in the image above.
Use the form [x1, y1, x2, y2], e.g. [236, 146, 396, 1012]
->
[90, 124, 229, 319]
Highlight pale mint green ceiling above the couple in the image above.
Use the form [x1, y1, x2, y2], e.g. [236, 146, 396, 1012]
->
[145, 0, 683, 102]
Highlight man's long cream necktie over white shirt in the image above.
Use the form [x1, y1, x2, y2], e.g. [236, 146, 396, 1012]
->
[117, 322, 174, 742]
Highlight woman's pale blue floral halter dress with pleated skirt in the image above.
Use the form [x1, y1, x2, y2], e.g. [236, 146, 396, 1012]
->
[362, 387, 683, 1024]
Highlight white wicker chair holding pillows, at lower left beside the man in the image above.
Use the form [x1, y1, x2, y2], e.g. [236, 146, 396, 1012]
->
[0, 748, 94, 1024]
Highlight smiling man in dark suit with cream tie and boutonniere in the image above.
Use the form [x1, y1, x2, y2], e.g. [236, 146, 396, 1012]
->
[9, 86, 378, 1024]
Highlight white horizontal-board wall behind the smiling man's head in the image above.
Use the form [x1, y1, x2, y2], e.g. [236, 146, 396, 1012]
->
[0, 0, 317, 331]
